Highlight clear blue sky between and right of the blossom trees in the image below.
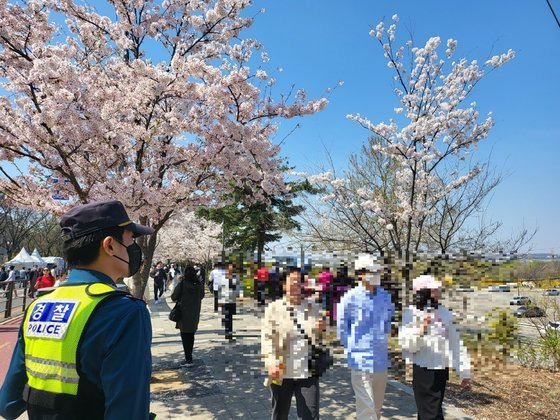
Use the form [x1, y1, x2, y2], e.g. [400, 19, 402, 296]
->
[245, 0, 560, 252]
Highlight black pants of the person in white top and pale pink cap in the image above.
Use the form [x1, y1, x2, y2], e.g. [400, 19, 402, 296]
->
[412, 364, 449, 420]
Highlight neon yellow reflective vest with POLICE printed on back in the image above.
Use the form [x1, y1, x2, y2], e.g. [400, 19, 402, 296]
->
[23, 283, 124, 395]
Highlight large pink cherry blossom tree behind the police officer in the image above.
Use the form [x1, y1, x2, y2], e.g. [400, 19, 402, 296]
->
[0, 0, 327, 296]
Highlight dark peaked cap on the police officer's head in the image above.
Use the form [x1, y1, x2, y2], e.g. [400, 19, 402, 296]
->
[60, 200, 155, 239]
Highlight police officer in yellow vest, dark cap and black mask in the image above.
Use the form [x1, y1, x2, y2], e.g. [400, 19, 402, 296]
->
[0, 201, 154, 420]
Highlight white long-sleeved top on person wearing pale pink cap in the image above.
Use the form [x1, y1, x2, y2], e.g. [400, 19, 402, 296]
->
[399, 305, 470, 378]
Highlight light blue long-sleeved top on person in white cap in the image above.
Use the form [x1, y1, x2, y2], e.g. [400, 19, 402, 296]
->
[337, 284, 395, 372]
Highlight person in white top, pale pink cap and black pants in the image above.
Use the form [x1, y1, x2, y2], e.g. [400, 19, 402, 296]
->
[399, 275, 470, 420]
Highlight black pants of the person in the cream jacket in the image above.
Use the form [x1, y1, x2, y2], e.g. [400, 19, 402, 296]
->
[270, 377, 319, 420]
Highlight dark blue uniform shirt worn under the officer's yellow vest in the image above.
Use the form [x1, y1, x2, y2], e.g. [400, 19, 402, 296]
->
[0, 269, 152, 420]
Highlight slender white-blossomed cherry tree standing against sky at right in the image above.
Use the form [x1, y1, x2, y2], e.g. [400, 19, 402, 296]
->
[315, 15, 515, 300]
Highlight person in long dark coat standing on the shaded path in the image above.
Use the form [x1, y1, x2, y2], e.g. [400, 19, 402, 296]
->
[171, 265, 204, 367]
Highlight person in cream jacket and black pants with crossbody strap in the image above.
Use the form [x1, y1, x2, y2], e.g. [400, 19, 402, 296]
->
[261, 267, 326, 420]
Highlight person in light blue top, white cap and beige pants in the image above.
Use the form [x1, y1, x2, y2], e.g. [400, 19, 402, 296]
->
[336, 254, 395, 420]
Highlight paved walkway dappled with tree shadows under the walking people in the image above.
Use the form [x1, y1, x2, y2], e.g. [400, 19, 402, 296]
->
[149, 292, 468, 420]
